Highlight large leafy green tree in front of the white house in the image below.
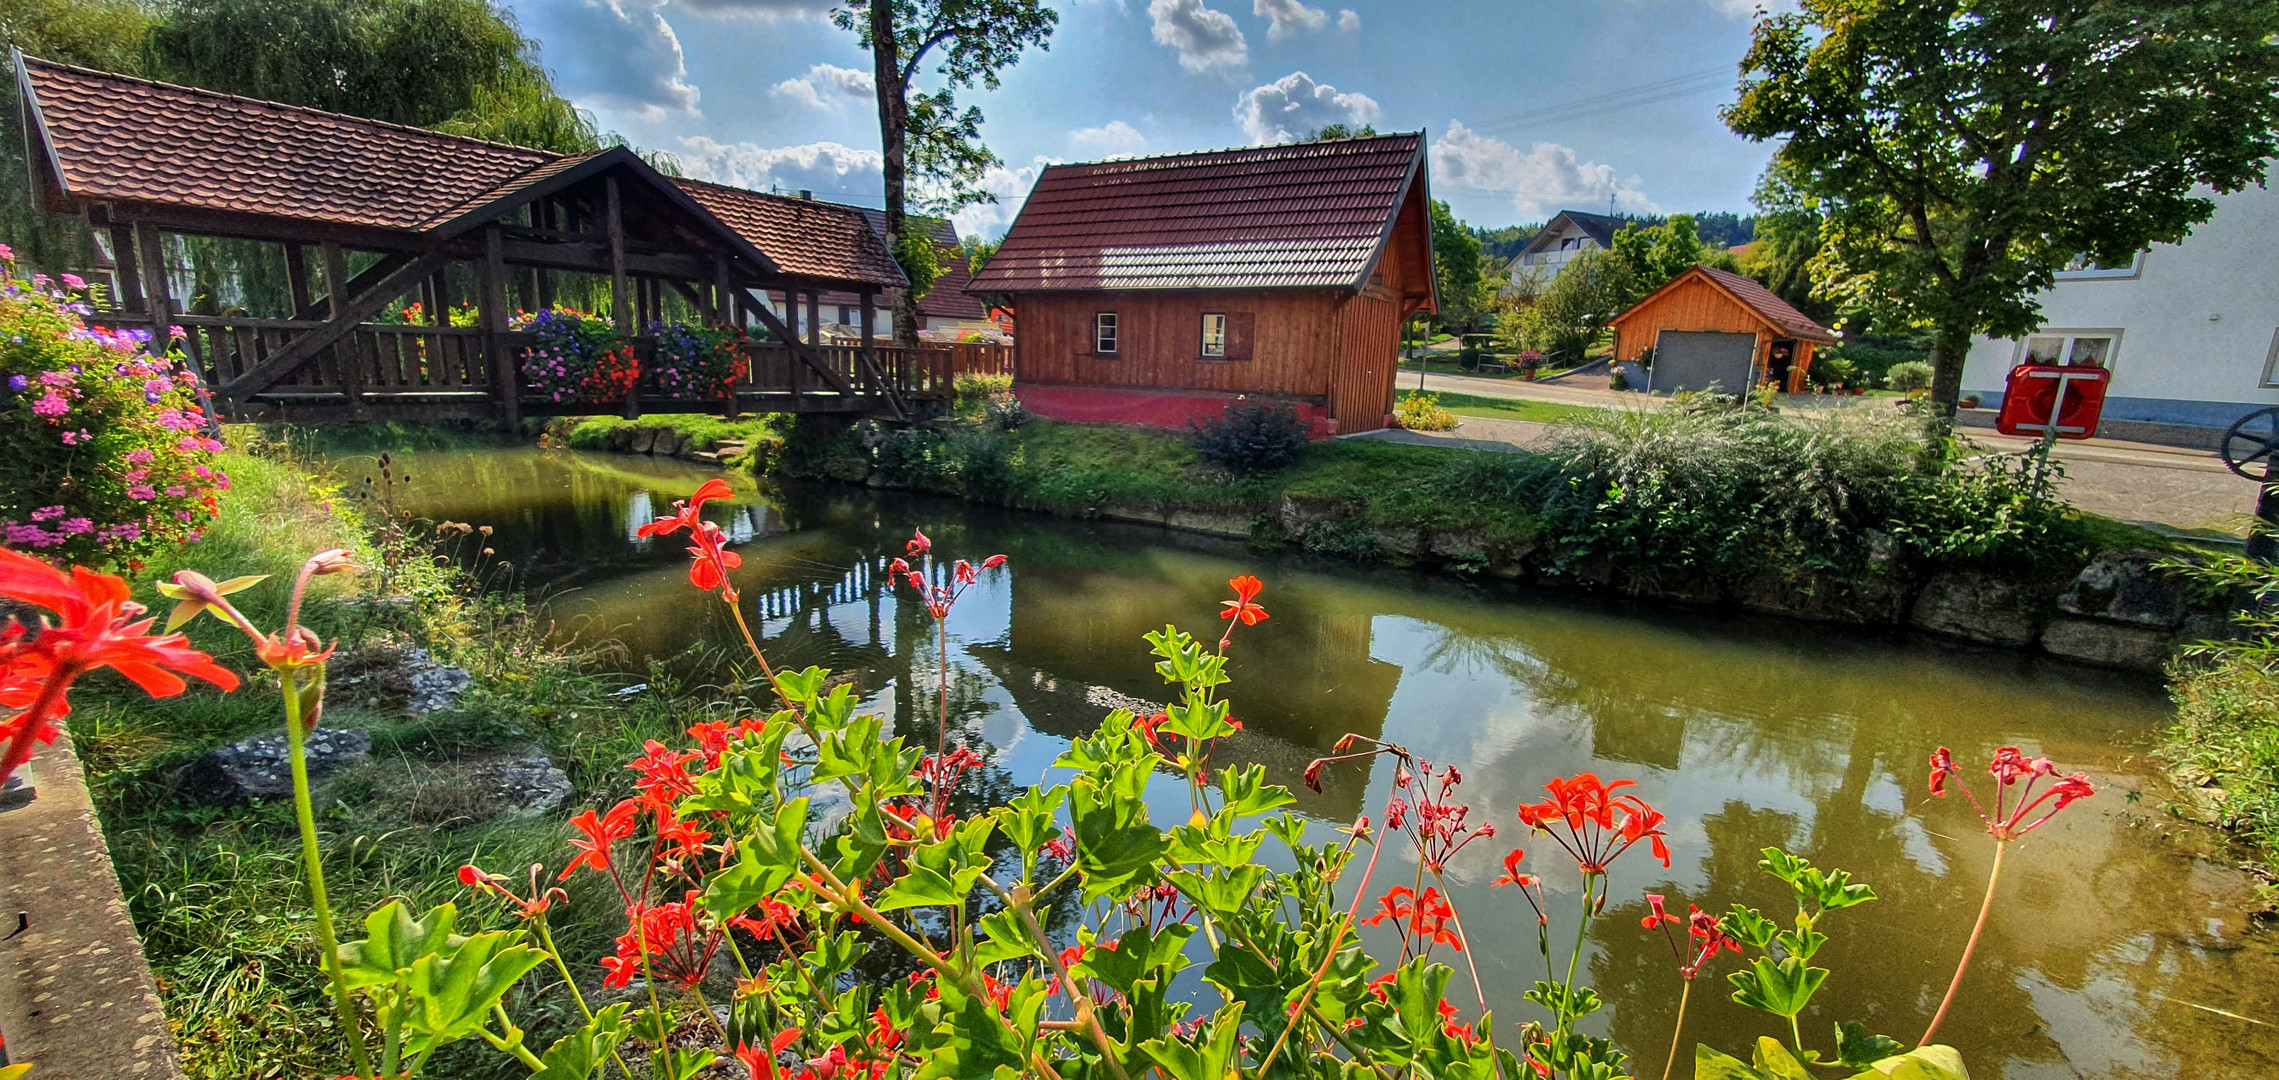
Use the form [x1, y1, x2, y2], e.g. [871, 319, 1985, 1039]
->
[1725, 0, 2279, 417]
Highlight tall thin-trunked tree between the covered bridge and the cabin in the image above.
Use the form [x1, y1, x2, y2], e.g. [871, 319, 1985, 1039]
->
[832, 0, 1060, 346]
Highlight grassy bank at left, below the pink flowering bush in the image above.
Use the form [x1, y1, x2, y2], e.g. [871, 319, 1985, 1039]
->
[71, 435, 686, 1080]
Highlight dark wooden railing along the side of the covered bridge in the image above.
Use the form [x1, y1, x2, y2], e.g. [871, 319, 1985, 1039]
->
[93, 314, 1012, 419]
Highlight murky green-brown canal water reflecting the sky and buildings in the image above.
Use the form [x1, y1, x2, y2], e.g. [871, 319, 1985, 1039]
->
[337, 447, 2279, 1080]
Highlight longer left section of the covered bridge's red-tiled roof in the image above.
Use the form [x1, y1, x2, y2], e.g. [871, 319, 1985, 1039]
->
[23, 57, 554, 230]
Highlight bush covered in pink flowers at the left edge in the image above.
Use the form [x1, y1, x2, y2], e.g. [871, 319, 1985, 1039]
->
[0, 255, 230, 565]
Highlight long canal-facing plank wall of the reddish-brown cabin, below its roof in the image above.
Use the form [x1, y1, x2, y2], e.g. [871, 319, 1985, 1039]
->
[1014, 292, 1340, 399]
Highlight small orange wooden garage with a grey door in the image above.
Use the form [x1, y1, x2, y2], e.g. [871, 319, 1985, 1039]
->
[1609, 264, 1837, 394]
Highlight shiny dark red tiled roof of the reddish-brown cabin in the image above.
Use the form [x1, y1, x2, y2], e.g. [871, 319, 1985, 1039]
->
[973, 134, 1424, 292]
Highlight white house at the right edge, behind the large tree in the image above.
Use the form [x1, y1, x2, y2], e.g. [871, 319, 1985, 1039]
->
[1962, 187, 2279, 428]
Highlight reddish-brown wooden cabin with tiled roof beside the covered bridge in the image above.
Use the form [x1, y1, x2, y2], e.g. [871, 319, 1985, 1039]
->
[966, 132, 1436, 435]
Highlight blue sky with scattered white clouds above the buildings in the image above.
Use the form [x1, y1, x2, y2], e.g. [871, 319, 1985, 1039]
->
[506, 0, 1778, 235]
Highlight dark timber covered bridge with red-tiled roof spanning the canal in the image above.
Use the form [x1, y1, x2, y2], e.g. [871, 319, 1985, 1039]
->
[14, 52, 989, 424]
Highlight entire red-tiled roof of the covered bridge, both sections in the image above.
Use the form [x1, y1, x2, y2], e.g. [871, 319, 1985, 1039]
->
[23, 57, 902, 287]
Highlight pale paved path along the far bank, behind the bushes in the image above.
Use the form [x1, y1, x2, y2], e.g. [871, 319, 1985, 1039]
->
[1356, 376, 2256, 538]
